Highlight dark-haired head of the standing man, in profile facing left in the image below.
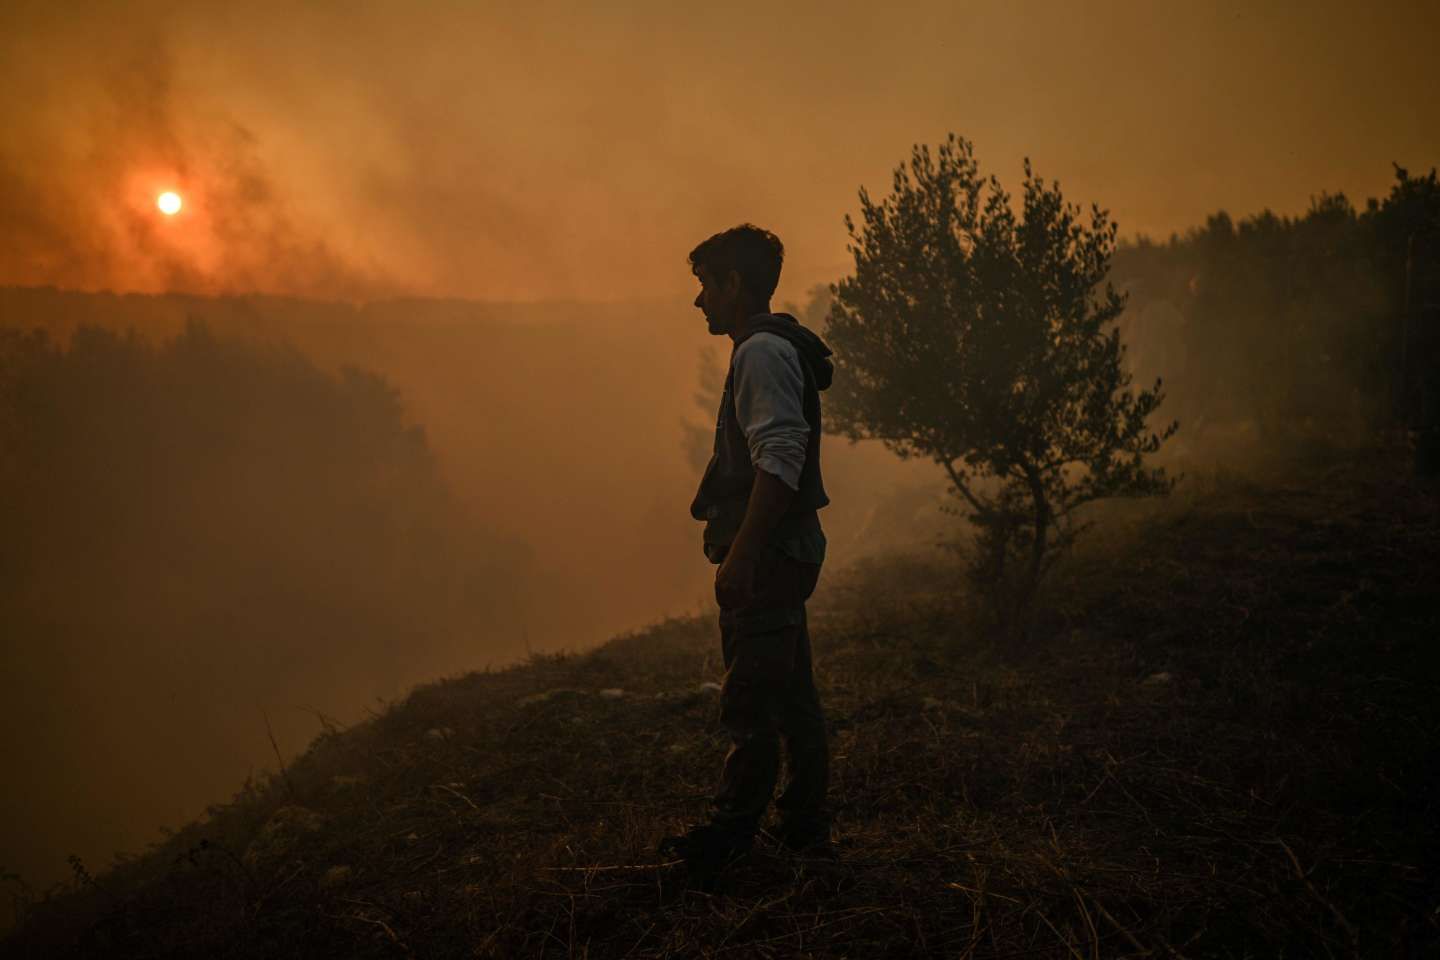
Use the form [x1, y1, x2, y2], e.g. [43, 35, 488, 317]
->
[690, 223, 785, 334]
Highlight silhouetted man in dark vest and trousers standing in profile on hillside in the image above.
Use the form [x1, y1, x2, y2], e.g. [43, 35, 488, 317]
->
[661, 223, 834, 885]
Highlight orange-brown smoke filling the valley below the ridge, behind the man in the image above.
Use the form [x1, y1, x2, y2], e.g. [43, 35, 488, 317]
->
[0, 288, 943, 915]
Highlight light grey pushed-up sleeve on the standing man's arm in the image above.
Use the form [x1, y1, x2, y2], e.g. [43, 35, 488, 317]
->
[733, 334, 809, 491]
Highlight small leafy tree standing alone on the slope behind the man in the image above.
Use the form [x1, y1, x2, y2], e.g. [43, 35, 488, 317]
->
[827, 134, 1176, 629]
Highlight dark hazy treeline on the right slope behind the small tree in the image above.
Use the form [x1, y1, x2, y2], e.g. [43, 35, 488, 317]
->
[1112, 168, 1440, 449]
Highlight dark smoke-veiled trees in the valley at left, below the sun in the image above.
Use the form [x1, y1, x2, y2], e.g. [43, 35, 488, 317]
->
[0, 324, 533, 892]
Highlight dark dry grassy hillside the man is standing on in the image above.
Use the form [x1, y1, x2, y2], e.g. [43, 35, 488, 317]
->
[7, 452, 1440, 957]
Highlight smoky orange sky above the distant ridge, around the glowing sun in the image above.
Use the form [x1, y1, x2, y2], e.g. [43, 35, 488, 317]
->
[0, 0, 1440, 299]
